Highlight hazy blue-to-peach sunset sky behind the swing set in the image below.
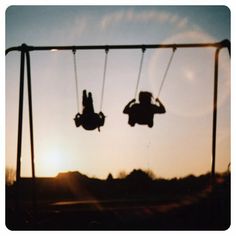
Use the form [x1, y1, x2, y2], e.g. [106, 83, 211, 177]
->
[6, 6, 231, 178]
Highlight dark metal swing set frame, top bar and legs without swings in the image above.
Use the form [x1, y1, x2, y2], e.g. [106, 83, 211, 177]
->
[5, 39, 231, 212]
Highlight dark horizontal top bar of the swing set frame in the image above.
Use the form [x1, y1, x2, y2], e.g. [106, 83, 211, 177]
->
[5, 39, 231, 55]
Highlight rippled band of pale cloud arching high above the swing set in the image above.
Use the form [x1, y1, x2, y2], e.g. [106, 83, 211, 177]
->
[100, 10, 188, 30]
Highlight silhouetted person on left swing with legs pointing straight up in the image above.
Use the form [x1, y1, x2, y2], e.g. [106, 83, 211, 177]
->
[74, 90, 105, 131]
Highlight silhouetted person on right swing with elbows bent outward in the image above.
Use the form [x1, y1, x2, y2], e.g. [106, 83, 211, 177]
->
[123, 91, 166, 128]
